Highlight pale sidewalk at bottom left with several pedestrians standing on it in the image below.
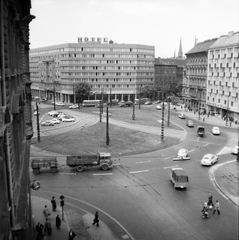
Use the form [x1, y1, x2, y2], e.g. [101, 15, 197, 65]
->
[31, 196, 117, 240]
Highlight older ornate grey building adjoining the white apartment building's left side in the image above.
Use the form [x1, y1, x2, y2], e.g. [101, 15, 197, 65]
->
[182, 38, 217, 113]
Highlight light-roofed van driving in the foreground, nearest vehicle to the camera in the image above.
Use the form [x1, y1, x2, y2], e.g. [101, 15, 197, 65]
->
[170, 168, 188, 188]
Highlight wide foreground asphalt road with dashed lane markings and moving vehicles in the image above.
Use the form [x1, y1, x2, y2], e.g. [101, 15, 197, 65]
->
[30, 104, 238, 240]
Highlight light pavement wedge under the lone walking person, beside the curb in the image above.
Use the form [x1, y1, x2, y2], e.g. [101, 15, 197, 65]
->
[82, 213, 118, 240]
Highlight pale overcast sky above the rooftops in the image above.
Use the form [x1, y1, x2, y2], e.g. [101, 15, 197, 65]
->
[30, 0, 239, 58]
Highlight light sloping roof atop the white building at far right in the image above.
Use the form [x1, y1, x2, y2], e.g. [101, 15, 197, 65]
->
[210, 32, 239, 49]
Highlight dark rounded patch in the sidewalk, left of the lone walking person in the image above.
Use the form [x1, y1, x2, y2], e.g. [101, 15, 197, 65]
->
[65, 209, 88, 239]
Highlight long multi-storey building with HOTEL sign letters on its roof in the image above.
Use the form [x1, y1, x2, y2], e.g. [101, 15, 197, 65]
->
[30, 41, 155, 103]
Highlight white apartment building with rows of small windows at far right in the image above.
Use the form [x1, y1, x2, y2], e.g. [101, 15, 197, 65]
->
[206, 32, 239, 120]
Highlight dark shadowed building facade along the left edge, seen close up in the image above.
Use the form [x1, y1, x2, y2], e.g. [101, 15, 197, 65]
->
[0, 0, 34, 240]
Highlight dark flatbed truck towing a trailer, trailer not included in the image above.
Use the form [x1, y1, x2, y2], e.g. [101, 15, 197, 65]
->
[66, 152, 113, 172]
